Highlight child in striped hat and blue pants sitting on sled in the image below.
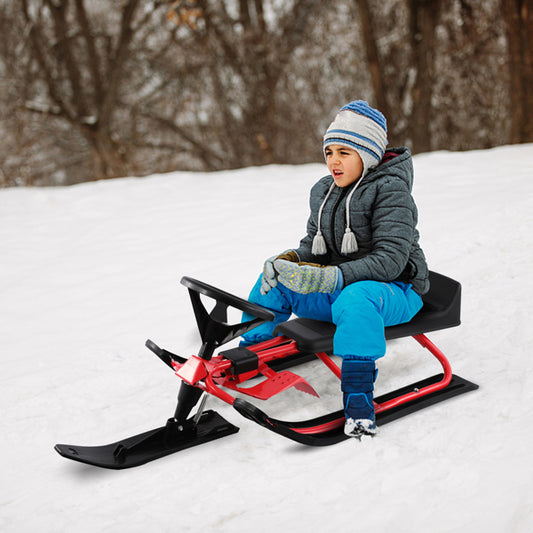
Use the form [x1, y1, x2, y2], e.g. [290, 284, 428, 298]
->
[244, 100, 429, 438]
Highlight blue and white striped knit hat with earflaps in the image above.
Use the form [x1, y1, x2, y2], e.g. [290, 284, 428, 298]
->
[324, 100, 387, 180]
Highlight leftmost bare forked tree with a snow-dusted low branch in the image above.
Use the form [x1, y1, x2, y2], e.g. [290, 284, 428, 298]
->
[22, 0, 143, 178]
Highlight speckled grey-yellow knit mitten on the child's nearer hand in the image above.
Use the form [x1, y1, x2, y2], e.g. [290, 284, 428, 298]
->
[274, 259, 342, 294]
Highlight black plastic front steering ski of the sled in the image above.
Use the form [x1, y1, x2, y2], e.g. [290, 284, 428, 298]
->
[54, 410, 239, 470]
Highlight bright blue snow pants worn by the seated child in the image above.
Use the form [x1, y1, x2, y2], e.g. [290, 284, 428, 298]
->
[243, 276, 422, 360]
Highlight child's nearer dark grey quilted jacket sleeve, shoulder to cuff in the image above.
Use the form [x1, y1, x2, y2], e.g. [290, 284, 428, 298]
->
[339, 180, 417, 285]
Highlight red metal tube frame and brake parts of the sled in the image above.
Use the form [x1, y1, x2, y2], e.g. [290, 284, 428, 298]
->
[172, 334, 452, 435]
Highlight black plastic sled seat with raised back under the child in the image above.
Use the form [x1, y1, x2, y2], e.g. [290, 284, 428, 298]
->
[275, 272, 461, 353]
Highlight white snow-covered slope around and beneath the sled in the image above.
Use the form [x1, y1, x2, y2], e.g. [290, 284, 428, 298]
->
[0, 145, 533, 533]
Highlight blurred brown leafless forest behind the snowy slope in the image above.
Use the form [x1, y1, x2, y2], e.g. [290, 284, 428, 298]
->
[0, 0, 533, 187]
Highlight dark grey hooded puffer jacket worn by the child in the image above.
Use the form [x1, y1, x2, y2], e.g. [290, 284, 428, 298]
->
[296, 147, 429, 294]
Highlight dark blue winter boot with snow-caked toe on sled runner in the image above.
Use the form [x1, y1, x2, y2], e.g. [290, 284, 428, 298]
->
[341, 359, 377, 439]
